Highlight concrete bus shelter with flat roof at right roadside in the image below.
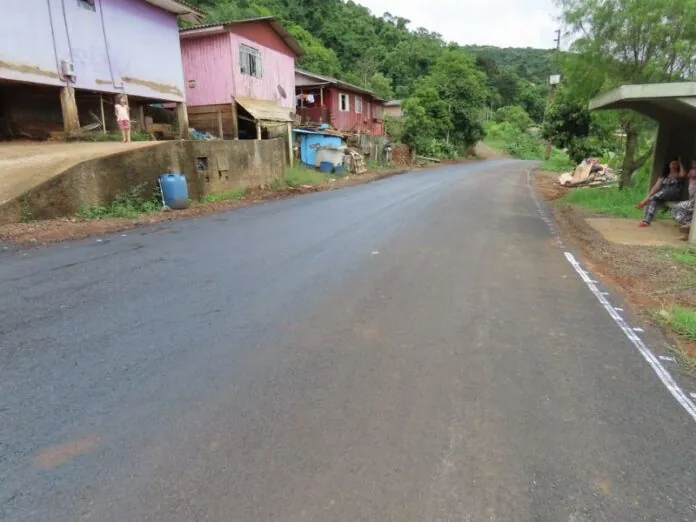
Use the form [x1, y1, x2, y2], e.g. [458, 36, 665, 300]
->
[590, 82, 696, 242]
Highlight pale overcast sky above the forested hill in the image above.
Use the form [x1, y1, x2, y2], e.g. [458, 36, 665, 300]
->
[355, 0, 559, 49]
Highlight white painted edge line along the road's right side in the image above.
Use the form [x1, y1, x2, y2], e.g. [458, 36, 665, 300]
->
[527, 169, 696, 422]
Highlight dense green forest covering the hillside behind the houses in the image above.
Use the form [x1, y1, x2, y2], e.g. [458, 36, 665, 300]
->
[189, 0, 551, 156]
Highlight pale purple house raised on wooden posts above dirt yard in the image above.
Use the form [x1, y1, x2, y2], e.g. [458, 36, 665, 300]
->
[0, 0, 204, 138]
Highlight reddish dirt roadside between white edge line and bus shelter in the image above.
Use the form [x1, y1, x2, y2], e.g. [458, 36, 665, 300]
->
[535, 172, 696, 356]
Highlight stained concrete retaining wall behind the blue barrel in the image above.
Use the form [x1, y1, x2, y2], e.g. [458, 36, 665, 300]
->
[0, 139, 288, 224]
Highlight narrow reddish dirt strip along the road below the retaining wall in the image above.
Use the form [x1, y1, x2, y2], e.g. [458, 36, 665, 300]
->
[0, 169, 414, 245]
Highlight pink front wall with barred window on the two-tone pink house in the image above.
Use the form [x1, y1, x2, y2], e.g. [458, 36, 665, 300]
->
[230, 34, 295, 109]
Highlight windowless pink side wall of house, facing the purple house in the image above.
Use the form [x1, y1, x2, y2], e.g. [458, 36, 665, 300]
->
[181, 33, 234, 106]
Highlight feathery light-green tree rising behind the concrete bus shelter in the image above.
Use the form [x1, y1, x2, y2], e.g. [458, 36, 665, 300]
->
[557, 0, 696, 187]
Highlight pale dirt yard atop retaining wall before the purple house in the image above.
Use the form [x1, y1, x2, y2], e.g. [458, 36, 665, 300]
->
[0, 141, 158, 205]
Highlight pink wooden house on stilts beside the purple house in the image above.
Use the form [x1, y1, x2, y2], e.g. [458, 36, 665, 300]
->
[179, 17, 303, 139]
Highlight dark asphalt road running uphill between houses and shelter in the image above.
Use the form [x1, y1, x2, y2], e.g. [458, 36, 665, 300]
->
[0, 161, 696, 522]
